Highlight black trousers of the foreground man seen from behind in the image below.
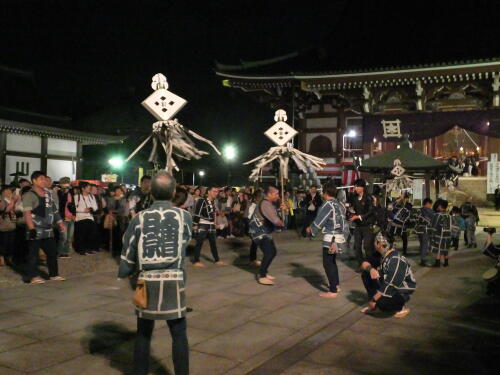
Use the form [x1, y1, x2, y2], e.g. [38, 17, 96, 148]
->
[134, 318, 189, 375]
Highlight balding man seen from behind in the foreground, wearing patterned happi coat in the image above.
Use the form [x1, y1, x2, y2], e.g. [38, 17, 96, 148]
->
[118, 171, 192, 375]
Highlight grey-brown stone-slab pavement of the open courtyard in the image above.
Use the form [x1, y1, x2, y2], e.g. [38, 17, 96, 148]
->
[0, 231, 500, 375]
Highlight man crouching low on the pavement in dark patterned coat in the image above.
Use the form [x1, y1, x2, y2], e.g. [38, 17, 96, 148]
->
[361, 233, 417, 318]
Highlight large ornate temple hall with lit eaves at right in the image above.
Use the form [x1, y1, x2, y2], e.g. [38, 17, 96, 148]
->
[216, 50, 500, 180]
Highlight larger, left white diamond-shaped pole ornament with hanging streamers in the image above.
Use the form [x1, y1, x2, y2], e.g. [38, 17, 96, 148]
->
[126, 73, 221, 173]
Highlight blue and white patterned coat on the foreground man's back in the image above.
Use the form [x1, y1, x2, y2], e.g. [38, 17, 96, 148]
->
[118, 201, 192, 320]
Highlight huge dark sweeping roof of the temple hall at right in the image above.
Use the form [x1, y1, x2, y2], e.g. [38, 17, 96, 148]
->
[215, 2, 500, 85]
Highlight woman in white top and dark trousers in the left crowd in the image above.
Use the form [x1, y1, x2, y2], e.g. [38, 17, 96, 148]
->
[74, 181, 100, 255]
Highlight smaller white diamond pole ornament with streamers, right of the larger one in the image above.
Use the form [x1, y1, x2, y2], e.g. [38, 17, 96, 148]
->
[243, 109, 326, 209]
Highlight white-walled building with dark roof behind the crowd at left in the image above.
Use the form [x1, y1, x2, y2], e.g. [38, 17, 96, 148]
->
[0, 65, 125, 184]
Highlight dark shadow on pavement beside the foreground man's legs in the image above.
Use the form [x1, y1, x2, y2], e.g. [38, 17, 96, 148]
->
[82, 322, 173, 375]
